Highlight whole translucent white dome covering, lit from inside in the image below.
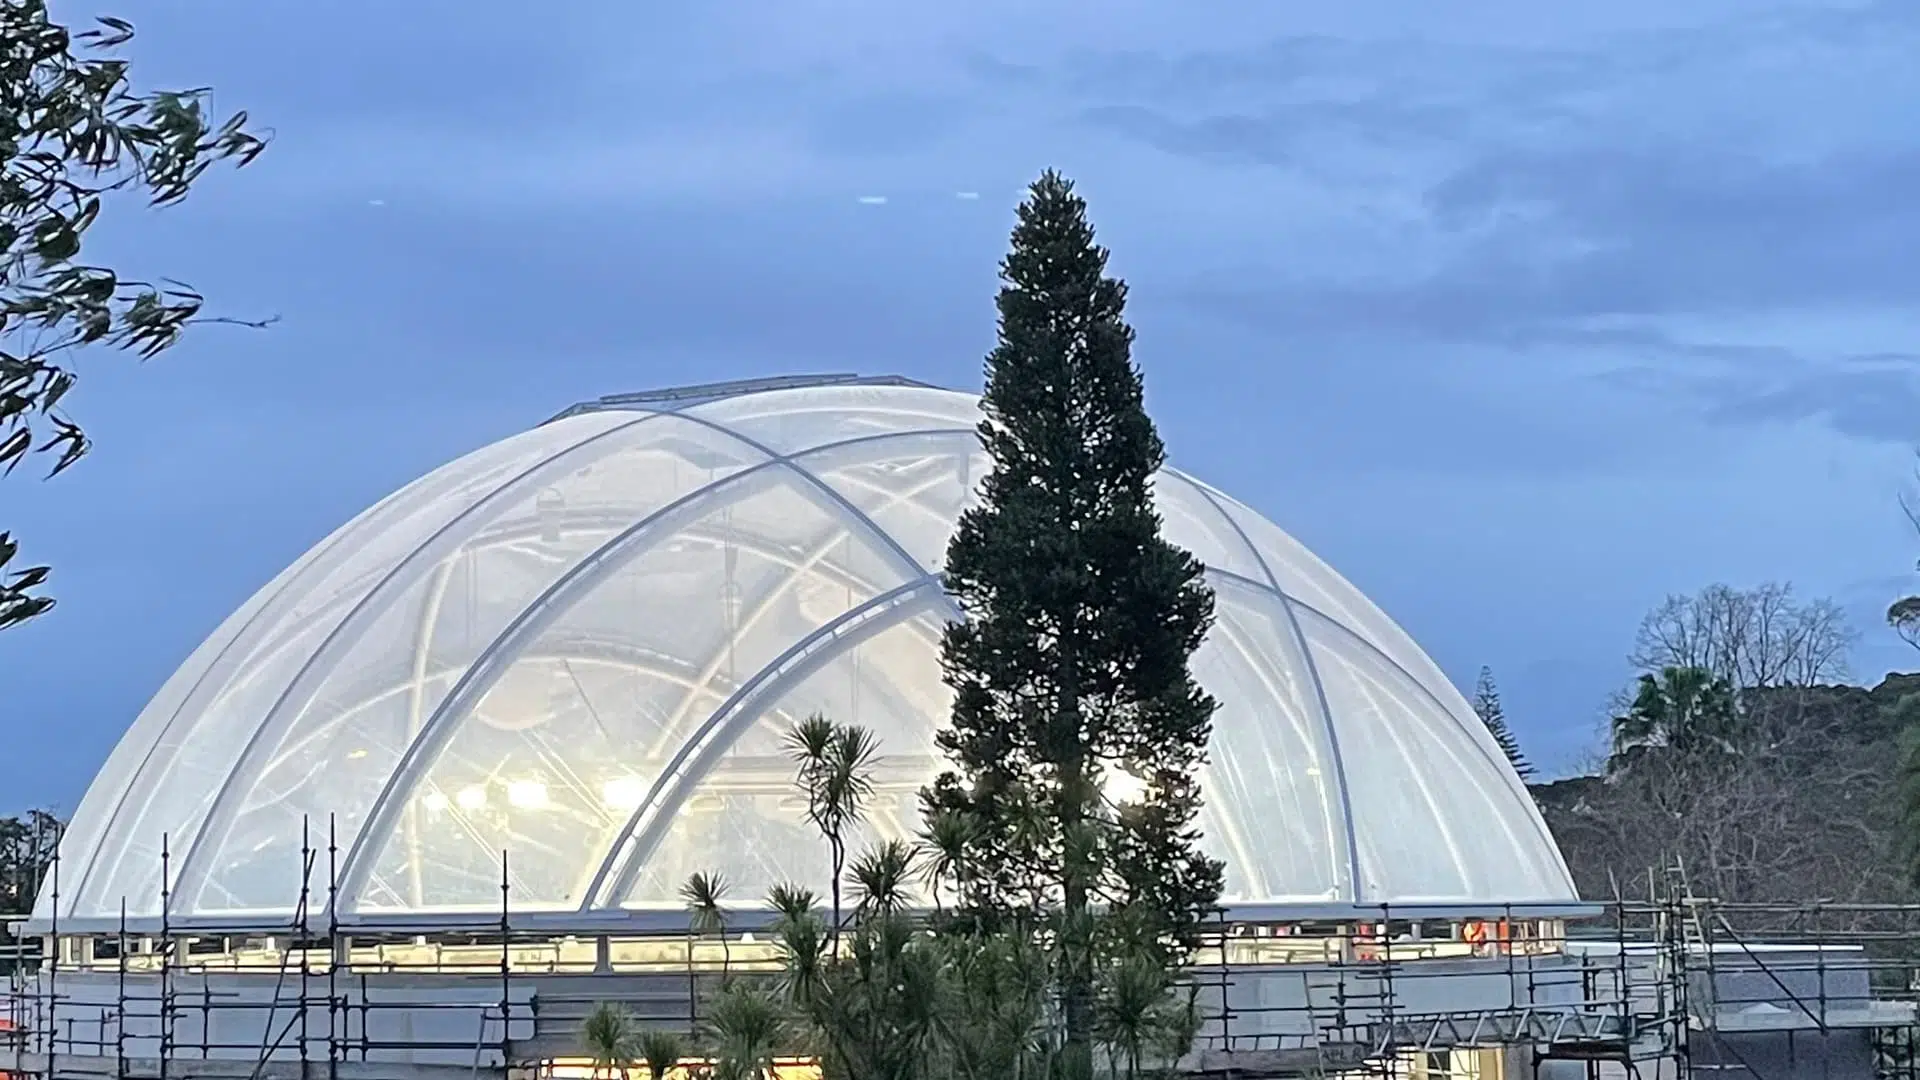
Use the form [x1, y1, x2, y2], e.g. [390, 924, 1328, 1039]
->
[35, 379, 1576, 922]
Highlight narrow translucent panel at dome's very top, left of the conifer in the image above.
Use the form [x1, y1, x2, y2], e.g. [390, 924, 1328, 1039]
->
[687, 386, 979, 454]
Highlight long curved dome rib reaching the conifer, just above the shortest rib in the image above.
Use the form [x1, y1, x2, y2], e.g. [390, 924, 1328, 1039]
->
[328, 424, 975, 903]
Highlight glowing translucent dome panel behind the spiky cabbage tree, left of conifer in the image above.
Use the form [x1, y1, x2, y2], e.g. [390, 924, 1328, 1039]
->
[620, 592, 950, 909]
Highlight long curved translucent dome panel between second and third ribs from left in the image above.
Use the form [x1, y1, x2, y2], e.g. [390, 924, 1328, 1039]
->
[182, 415, 764, 911]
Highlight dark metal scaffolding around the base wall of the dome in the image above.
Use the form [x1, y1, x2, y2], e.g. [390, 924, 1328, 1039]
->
[11, 840, 1920, 1080]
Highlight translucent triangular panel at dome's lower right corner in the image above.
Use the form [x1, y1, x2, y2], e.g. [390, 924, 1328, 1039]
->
[1300, 613, 1574, 901]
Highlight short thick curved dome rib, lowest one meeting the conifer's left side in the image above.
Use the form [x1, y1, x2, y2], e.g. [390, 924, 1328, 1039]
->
[582, 575, 950, 911]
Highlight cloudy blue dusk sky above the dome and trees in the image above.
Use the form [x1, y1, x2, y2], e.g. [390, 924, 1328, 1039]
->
[0, 0, 1920, 809]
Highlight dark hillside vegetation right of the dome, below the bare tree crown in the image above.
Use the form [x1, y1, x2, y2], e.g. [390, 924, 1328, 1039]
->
[1532, 669, 1920, 903]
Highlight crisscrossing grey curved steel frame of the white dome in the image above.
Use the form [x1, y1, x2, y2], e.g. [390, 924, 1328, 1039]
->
[56, 382, 1565, 915]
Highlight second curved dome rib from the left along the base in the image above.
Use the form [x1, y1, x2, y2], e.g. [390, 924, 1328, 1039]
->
[175, 413, 679, 903]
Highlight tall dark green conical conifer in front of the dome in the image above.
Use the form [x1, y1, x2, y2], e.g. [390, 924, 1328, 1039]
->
[925, 171, 1221, 1076]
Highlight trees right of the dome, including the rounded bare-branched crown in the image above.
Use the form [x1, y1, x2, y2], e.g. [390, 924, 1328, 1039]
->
[1475, 584, 1920, 903]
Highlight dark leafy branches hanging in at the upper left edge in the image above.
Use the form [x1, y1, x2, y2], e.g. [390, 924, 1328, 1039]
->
[0, 0, 273, 628]
